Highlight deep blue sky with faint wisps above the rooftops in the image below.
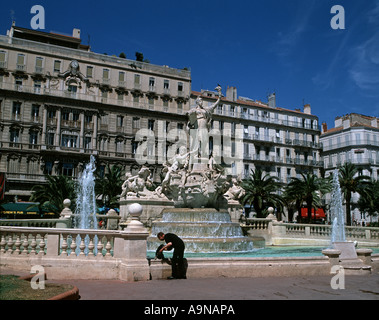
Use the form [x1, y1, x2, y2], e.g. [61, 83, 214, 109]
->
[0, 0, 379, 127]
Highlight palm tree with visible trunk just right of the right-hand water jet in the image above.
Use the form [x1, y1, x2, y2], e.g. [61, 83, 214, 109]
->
[339, 162, 370, 226]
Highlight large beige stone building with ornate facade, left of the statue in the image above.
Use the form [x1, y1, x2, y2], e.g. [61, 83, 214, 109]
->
[0, 25, 191, 200]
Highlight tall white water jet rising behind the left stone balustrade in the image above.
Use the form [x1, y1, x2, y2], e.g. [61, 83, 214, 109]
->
[74, 155, 97, 254]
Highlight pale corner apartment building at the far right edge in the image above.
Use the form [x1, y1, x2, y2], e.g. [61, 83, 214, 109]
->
[320, 113, 379, 222]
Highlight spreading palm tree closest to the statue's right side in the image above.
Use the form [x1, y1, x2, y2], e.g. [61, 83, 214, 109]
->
[241, 169, 284, 218]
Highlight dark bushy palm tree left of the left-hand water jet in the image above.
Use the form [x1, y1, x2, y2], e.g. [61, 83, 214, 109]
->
[30, 175, 75, 215]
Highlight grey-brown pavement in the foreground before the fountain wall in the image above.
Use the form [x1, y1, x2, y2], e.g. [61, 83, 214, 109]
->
[0, 270, 379, 305]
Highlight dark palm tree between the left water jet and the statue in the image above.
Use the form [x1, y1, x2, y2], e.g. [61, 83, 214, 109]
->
[95, 164, 123, 208]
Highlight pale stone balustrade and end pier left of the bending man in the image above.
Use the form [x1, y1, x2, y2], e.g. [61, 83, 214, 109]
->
[0, 226, 149, 281]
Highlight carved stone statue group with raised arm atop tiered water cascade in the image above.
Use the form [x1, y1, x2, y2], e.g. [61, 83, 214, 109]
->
[120, 86, 253, 253]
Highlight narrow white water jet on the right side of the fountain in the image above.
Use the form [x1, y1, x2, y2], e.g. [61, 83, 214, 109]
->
[330, 169, 346, 243]
